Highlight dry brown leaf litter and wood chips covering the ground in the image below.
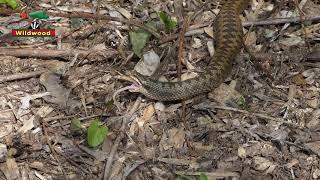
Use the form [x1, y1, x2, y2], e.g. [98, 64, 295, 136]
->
[0, 0, 320, 179]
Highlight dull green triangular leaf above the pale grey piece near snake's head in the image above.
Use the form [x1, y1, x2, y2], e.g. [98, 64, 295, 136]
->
[129, 29, 151, 58]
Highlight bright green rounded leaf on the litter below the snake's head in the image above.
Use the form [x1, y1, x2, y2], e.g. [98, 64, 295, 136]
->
[87, 119, 108, 147]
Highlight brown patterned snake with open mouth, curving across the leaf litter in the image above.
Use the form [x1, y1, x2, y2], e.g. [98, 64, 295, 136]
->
[132, 0, 250, 101]
